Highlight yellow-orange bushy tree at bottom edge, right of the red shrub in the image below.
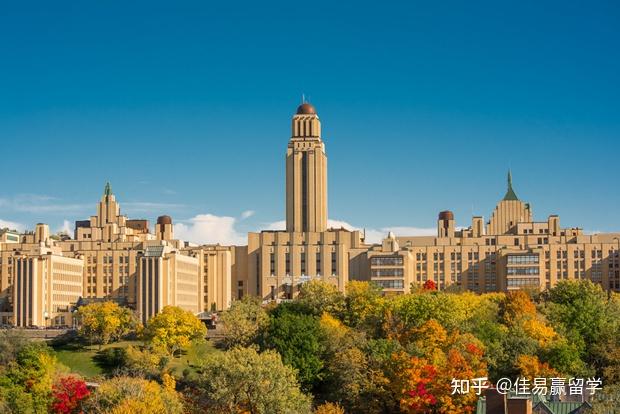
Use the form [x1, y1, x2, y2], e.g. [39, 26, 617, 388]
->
[84, 376, 184, 414]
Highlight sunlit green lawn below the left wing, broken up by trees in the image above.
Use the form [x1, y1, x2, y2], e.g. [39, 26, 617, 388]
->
[54, 341, 219, 379]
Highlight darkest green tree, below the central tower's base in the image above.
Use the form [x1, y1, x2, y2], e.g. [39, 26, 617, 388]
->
[263, 312, 323, 390]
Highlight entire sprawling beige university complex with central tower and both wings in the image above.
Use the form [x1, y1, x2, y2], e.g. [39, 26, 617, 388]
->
[0, 103, 620, 327]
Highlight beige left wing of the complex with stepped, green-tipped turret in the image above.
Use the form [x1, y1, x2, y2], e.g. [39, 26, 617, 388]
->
[0, 183, 236, 326]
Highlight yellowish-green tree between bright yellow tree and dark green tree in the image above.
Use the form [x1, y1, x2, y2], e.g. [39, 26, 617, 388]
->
[222, 296, 269, 348]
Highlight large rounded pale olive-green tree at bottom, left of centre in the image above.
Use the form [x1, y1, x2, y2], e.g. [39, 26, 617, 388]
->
[194, 348, 311, 414]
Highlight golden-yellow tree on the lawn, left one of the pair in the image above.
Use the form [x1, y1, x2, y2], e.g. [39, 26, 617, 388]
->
[77, 302, 137, 345]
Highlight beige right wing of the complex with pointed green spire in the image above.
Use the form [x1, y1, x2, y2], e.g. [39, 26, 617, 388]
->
[368, 173, 620, 294]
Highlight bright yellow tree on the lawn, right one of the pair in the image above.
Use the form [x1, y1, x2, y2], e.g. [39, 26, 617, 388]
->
[144, 306, 207, 356]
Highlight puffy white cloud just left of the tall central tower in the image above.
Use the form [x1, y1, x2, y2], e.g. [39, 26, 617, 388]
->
[174, 214, 247, 245]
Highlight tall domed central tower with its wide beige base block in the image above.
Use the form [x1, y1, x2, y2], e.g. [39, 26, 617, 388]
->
[247, 102, 368, 301]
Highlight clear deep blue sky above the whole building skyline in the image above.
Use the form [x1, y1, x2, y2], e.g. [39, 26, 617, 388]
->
[0, 1, 620, 242]
